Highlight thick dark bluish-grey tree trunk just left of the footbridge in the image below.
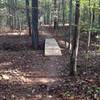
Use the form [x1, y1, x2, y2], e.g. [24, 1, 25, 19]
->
[32, 0, 39, 50]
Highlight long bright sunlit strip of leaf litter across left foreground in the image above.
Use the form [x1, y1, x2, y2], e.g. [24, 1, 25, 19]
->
[0, 69, 58, 85]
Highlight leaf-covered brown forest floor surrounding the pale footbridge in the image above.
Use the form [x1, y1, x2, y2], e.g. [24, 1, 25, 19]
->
[0, 28, 100, 100]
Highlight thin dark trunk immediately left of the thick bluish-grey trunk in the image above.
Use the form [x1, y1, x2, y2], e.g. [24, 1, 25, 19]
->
[26, 0, 31, 36]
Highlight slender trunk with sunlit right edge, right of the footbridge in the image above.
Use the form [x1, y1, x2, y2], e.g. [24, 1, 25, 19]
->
[70, 0, 80, 76]
